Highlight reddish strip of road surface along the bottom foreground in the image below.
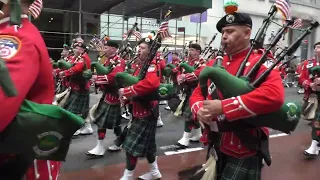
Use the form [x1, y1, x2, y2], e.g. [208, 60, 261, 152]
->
[59, 133, 320, 180]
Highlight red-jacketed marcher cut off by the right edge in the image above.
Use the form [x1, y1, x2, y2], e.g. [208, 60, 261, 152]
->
[299, 42, 320, 156]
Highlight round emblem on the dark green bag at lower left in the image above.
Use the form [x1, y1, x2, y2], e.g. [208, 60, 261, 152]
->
[33, 131, 63, 156]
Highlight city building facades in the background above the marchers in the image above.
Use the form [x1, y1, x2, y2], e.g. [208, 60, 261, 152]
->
[38, 0, 320, 59]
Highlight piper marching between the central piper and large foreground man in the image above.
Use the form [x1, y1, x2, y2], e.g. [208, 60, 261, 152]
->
[177, 44, 205, 148]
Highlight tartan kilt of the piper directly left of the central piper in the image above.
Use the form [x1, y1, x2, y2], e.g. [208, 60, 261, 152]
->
[94, 101, 121, 129]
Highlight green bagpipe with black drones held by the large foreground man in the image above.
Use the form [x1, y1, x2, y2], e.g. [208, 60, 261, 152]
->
[199, 22, 319, 133]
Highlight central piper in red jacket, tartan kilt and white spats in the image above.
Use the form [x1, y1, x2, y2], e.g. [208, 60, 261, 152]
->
[119, 37, 162, 180]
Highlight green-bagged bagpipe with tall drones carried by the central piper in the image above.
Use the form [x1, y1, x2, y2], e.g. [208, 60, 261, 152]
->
[115, 9, 173, 101]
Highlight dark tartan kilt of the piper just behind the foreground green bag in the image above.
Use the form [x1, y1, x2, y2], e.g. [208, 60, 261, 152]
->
[64, 90, 90, 119]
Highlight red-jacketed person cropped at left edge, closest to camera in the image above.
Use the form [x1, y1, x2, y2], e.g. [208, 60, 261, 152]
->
[0, 0, 61, 180]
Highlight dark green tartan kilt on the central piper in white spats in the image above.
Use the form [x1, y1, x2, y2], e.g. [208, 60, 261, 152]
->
[122, 116, 157, 157]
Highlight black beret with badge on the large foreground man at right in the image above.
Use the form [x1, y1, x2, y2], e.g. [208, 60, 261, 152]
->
[216, 12, 252, 33]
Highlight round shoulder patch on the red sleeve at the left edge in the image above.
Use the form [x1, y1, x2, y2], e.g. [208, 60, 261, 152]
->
[0, 35, 21, 60]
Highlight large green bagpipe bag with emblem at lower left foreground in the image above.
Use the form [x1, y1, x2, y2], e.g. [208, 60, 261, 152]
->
[0, 100, 85, 161]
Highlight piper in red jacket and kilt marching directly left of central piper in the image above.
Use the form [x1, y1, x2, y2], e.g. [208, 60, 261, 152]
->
[86, 40, 125, 157]
